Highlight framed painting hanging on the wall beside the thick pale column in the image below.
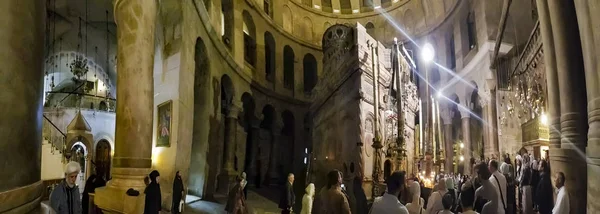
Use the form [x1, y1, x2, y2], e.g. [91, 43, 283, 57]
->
[156, 100, 173, 147]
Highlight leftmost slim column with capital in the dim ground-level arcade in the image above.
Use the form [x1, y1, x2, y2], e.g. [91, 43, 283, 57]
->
[218, 104, 242, 194]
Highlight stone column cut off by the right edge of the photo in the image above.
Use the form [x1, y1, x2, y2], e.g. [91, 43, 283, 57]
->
[575, 0, 600, 213]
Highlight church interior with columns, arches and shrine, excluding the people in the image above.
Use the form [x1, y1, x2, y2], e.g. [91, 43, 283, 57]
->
[0, 0, 600, 214]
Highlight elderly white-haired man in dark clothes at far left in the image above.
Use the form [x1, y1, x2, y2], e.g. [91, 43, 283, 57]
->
[50, 162, 81, 214]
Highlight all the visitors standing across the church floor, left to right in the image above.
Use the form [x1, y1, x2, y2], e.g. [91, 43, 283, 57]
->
[50, 151, 569, 214]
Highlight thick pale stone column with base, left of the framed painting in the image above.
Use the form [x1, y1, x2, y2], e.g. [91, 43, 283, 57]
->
[95, 0, 157, 213]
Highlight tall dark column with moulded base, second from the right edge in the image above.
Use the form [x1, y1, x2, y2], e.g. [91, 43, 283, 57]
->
[548, 0, 587, 213]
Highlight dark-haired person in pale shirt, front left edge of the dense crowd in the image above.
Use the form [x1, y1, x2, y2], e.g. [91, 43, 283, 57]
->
[369, 172, 408, 214]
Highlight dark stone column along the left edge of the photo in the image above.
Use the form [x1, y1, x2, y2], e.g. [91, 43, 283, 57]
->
[0, 0, 44, 213]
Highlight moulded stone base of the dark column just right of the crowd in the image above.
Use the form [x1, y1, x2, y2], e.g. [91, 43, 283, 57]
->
[549, 148, 588, 213]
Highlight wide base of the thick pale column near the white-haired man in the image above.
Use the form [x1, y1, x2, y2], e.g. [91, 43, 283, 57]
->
[94, 168, 149, 213]
